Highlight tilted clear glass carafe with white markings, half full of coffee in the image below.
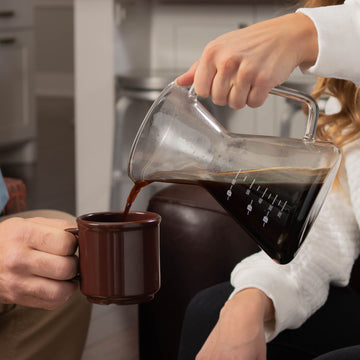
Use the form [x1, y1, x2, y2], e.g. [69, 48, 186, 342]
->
[128, 82, 341, 264]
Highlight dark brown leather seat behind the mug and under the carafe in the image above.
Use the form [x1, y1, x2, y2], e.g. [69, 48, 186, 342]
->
[139, 185, 360, 360]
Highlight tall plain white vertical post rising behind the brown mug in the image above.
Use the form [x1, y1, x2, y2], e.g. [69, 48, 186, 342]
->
[74, 0, 115, 213]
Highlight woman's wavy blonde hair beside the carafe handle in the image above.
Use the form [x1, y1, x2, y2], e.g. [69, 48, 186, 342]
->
[300, 0, 360, 148]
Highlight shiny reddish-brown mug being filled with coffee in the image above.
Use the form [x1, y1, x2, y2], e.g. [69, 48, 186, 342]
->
[66, 211, 161, 305]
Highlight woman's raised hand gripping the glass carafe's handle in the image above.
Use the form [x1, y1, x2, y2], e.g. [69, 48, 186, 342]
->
[178, 13, 318, 109]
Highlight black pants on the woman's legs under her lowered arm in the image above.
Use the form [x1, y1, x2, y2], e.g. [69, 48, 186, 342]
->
[178, 282, 360, 360]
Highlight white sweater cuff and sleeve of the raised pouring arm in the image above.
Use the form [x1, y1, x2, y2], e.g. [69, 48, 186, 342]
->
[298, 0, 360, 87]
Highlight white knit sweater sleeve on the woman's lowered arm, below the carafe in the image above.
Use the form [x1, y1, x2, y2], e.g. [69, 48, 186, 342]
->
[231, 143, 360, 341]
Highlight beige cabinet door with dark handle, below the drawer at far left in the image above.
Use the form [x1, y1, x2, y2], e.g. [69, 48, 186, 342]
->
[0, 30, 36, 146]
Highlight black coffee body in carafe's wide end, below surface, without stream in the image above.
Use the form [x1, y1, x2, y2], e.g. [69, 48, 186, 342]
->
[202, 181, 322, 264]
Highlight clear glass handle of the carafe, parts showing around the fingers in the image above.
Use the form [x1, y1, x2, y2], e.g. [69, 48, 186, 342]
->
[189, 85, 319, 141]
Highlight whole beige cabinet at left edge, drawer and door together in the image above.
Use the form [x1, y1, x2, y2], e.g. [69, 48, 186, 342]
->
[0, 0, 36, 163]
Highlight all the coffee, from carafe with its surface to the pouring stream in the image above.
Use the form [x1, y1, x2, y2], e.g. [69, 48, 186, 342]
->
[127, 168, 328, 264]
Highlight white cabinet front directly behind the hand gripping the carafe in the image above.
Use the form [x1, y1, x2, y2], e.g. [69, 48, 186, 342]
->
[151, 3, 255, 71]
